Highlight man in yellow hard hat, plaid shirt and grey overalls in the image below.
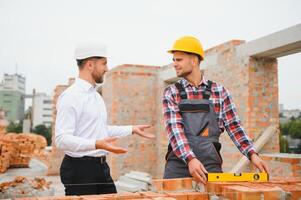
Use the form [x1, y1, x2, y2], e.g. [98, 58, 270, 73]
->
[163, 36, 268, 183]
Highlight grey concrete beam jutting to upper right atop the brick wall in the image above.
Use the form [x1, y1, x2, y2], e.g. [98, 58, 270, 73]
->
[236, 24, 301, 58]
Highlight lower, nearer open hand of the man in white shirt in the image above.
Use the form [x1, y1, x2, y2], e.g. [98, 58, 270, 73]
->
[95, 137, 127, 154]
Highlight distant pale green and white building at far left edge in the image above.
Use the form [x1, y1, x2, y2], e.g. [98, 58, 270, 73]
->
[0, 74, 25, 121]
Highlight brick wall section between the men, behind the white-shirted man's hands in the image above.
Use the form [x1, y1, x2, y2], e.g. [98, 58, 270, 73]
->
[102, 65, 159, 177]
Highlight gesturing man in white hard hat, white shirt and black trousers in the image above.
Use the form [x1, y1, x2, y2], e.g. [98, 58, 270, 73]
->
[55, 43, 154, 195]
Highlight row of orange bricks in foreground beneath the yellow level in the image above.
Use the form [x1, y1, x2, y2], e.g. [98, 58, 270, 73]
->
[14, 178, 301, 200]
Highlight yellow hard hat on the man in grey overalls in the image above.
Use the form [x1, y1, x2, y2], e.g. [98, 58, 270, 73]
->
[167, 36, 204, 60]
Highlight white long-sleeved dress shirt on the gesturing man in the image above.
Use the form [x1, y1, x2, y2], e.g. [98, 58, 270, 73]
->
[55, 78, 132, 157]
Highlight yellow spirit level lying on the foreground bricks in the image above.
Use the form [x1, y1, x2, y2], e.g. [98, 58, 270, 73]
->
[207, 173, 269, 182]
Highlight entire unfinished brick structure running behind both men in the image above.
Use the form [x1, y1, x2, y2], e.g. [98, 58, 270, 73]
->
[53, 40, 279, 178]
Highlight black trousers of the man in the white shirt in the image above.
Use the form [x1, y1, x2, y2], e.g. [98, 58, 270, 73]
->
[60, 155, 117, 195]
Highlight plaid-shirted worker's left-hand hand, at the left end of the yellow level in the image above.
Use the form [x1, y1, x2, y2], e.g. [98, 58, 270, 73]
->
[188, 158, 208, 184]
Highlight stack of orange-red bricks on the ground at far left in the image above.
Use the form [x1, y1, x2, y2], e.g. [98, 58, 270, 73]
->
[0, 133, 47, 173]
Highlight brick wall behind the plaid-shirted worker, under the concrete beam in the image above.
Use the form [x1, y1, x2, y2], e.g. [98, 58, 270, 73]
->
[201, 40, 279, 171]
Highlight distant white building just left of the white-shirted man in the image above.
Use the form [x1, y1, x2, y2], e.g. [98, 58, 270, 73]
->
[31, 93, 52, 128]
